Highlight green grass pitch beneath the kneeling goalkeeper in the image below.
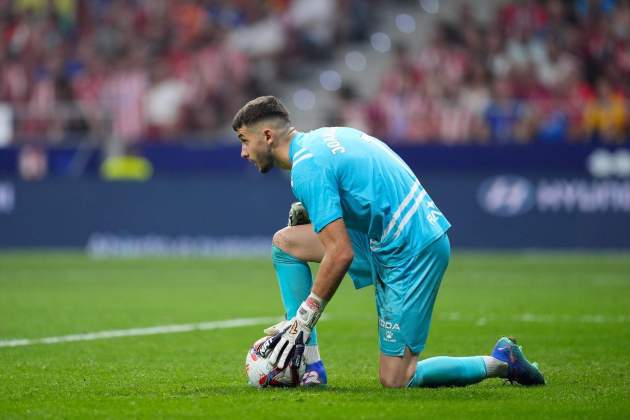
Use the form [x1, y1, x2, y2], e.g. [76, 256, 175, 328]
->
[0, 252, 630, 419]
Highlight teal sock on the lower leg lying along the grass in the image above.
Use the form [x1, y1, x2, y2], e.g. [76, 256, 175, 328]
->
[408, 356, 487, 387]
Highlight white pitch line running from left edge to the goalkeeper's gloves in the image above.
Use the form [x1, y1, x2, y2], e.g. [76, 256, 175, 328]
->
[0, 317, 282, 347]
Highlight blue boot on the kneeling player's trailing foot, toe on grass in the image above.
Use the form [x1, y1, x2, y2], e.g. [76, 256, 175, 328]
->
[492, 337, 545, 386]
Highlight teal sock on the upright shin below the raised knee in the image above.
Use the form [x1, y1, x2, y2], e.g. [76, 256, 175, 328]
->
[271, 245, 317, 346]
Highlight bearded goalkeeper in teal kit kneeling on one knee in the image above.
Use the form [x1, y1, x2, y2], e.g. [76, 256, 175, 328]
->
[232, 96, 544, 388]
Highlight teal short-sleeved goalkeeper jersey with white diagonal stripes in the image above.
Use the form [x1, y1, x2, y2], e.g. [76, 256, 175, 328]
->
[289, 127, 450, 265]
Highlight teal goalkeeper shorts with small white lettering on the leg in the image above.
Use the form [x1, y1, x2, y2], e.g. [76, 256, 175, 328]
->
[348, 231, 451, 356]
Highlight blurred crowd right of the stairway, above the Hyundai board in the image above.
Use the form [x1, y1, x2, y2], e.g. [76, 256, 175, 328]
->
[330, 0, 630, 144]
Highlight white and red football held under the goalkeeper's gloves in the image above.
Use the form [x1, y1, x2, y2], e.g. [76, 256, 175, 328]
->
[245, 336, 306, 388]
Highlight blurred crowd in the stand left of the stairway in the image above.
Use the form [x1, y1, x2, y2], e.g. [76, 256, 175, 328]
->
[0, 0, 370, 146]
